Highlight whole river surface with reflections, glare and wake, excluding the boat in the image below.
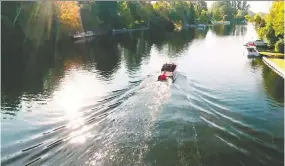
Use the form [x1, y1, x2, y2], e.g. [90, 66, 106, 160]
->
[1, 25, 284, 166]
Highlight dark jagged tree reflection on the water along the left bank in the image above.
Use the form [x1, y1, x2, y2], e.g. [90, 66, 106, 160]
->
[1, 29, 197, 118]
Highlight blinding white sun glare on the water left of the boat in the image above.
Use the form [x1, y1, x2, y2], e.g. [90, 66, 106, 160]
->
[52, 70, 104, 143]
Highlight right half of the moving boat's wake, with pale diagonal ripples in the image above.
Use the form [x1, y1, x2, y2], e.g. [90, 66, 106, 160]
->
[172, 73, 284, 165]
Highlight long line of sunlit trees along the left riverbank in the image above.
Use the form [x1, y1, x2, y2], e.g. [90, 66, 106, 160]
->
[1, 1, 249, 46]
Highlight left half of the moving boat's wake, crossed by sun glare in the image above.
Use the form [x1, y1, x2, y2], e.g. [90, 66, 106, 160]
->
[1, 74, 170, 165]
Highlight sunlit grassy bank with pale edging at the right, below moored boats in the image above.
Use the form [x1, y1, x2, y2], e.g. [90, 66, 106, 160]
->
[262, 57, 285, 78]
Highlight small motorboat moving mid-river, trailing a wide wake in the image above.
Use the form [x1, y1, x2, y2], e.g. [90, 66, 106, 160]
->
[158, 63, 177, 82]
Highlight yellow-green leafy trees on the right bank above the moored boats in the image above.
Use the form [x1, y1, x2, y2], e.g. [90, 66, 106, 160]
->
[246, 1, 284, 53]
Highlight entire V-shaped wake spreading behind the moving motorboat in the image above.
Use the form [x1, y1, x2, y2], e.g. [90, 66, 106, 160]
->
[1, 73, 284, 165]
